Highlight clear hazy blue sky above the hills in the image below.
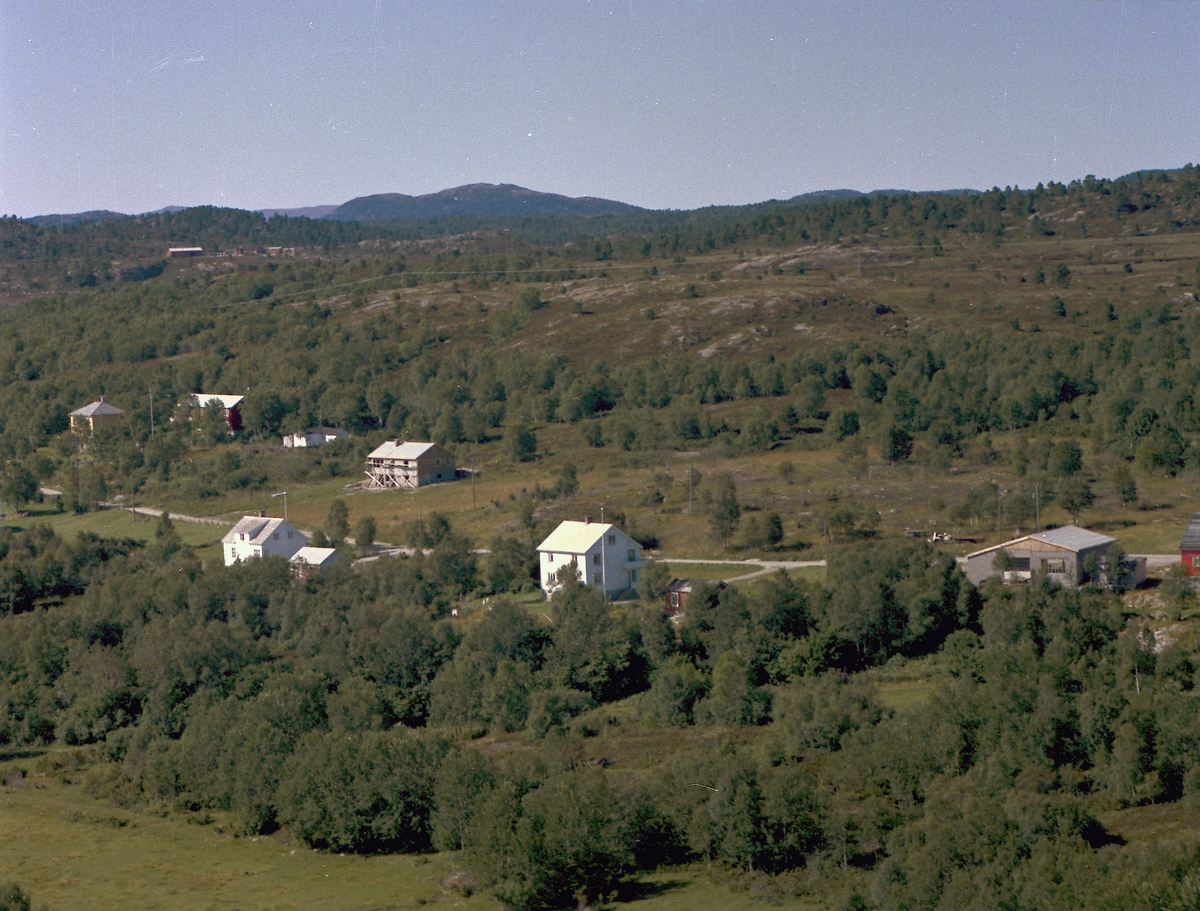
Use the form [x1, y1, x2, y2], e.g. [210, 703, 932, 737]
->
[0, 0, 1200, 216]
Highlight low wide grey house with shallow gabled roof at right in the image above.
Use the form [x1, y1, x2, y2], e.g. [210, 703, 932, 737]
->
[966, 525, 1146, 588]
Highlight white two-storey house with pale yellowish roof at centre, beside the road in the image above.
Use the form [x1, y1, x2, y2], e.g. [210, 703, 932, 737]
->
[538, 519, 646, 598]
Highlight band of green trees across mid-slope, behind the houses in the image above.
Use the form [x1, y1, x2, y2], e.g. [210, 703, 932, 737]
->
[0, 265, 1200, 520]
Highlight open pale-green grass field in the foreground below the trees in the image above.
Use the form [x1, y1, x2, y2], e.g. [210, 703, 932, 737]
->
[0, 753, 817, 911]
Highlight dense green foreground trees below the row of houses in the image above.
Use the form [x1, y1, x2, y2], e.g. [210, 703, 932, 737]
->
[0, 522, 1200, 909]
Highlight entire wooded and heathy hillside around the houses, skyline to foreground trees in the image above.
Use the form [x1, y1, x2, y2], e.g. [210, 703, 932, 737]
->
[0, 167, 1200, 909]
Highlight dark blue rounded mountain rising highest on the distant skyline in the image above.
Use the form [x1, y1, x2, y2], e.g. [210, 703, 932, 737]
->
[326, 184, 644, 221]
